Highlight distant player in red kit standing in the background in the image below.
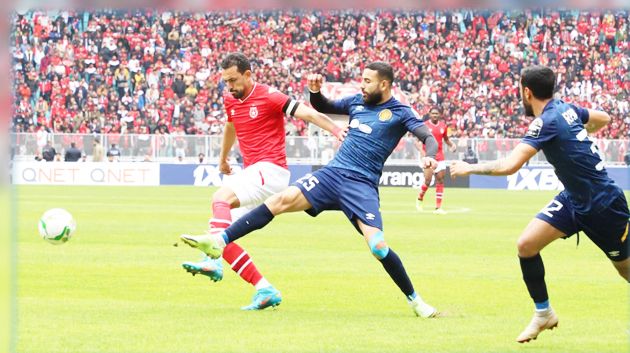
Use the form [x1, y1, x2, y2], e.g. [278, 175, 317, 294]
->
[416, 107, 457, 214]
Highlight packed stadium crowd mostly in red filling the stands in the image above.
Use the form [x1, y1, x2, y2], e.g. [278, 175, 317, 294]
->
[12, 10, 630, 139]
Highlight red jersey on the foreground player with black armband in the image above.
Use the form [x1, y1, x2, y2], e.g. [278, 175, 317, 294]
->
[224, 83, 298, 169]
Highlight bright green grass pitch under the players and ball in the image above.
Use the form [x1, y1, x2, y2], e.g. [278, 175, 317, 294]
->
[15, 186, 629, 353]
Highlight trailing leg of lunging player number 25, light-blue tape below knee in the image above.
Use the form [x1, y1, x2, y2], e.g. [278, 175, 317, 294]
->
[356, 219, 438, 318]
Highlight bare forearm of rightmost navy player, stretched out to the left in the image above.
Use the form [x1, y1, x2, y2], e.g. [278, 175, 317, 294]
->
[450, 143, 538, 178]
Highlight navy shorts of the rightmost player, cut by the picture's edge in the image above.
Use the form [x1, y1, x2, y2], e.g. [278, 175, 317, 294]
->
[536, 192, 630, 261]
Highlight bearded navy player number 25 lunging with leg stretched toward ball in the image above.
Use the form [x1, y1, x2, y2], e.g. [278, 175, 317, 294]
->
[181, 62, 437, 317]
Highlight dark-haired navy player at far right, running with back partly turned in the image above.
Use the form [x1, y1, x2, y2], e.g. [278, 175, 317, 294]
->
[451, 66, 630, 343]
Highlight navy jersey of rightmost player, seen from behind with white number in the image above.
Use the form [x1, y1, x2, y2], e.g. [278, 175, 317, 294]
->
[522, 99, 621, 213]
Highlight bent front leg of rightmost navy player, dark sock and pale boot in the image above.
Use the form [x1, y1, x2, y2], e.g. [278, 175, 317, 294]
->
[516, 218, 565, 343]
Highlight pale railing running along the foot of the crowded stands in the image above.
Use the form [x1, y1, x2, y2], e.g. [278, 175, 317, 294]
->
[10, 133, 630, 165]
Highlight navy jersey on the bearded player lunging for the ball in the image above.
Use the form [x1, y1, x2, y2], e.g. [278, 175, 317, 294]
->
[328, 94, 424, 185]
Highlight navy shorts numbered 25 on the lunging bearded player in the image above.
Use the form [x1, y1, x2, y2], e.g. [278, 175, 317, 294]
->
[293, 167, 383, 233]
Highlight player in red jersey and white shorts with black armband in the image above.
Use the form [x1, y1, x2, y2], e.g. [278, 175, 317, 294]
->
[182, 53, 346, 310]
